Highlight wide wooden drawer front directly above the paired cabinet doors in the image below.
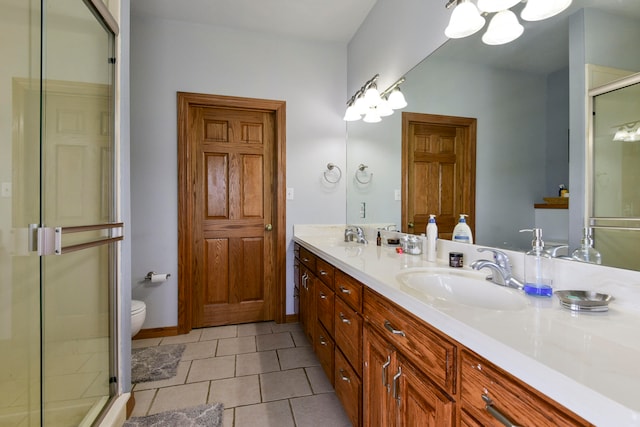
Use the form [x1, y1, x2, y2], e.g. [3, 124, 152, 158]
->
[363, 289, 457, 395]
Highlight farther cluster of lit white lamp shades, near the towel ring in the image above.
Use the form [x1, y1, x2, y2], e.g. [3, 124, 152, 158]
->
[343, 74, 407, 123]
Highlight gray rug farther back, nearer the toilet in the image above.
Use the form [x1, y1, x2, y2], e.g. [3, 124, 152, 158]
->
[131, 344, 186, 384]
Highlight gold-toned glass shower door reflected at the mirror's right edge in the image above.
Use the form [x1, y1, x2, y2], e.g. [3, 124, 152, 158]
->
[591, 74, 640, 270]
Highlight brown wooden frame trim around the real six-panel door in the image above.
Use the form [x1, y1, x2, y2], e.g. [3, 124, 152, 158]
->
[177, 92, 286, 334]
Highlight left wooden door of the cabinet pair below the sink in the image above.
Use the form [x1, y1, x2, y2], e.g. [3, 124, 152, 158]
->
[362, 327, 395, 427]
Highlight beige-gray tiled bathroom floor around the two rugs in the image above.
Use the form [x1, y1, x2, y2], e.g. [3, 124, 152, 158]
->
[132, 322, 351, 427]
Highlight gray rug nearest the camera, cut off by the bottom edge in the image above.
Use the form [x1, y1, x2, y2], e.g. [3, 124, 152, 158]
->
[123, 403, 224, 427]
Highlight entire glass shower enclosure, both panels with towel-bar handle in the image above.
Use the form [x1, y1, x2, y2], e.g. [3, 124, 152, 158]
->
[0, 0, 122, 426]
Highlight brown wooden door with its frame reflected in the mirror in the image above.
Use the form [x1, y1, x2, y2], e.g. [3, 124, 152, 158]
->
[402, 113, 476, 239]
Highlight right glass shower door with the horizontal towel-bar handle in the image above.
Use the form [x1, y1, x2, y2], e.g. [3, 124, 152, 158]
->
[39, 0, 119, 426]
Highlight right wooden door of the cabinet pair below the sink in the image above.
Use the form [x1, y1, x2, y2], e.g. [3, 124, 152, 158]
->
[391, 357, 455, 427]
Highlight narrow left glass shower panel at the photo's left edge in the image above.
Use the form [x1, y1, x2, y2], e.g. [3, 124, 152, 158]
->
[0, 0, 41, 426]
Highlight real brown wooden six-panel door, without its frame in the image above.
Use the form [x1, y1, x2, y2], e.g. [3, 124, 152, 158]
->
[180, 93, 281, 328]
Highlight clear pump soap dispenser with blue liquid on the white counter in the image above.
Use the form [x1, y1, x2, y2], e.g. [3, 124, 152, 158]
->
[520, 228, 553, 297]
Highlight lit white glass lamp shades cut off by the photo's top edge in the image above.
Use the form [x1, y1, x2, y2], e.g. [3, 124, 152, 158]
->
[444, 0, 572, 45]
